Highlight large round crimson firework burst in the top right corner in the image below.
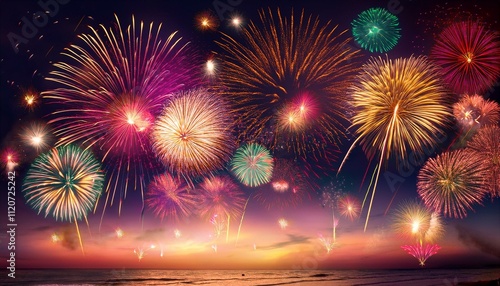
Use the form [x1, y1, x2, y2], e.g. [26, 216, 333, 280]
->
[431, 21, 500, 94]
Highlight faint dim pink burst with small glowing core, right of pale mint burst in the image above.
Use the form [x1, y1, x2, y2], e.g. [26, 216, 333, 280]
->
[254, 158, 307, 209]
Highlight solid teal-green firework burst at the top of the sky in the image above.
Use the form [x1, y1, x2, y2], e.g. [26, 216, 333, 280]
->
[351, 8, 401, 53]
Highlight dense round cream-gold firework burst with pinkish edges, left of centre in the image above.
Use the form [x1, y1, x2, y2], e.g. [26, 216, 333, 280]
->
[152, 89, 234, 179]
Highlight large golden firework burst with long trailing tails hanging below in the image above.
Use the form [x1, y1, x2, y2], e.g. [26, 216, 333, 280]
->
[339, 57, 451, 230]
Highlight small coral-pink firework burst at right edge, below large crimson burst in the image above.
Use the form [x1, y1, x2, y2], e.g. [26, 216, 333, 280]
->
[453, 94, 500, 130]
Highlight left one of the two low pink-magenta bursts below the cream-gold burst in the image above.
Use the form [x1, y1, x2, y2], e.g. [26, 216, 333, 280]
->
[145, 173, 196, 220]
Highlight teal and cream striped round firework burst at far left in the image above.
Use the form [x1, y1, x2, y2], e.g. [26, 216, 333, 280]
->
[23, 145, 104, 222]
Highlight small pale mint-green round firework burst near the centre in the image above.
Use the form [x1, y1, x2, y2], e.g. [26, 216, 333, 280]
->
[231, 143, 274, 187]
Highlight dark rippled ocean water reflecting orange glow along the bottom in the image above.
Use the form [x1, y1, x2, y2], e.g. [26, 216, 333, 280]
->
[0, 268, 500, 286]
